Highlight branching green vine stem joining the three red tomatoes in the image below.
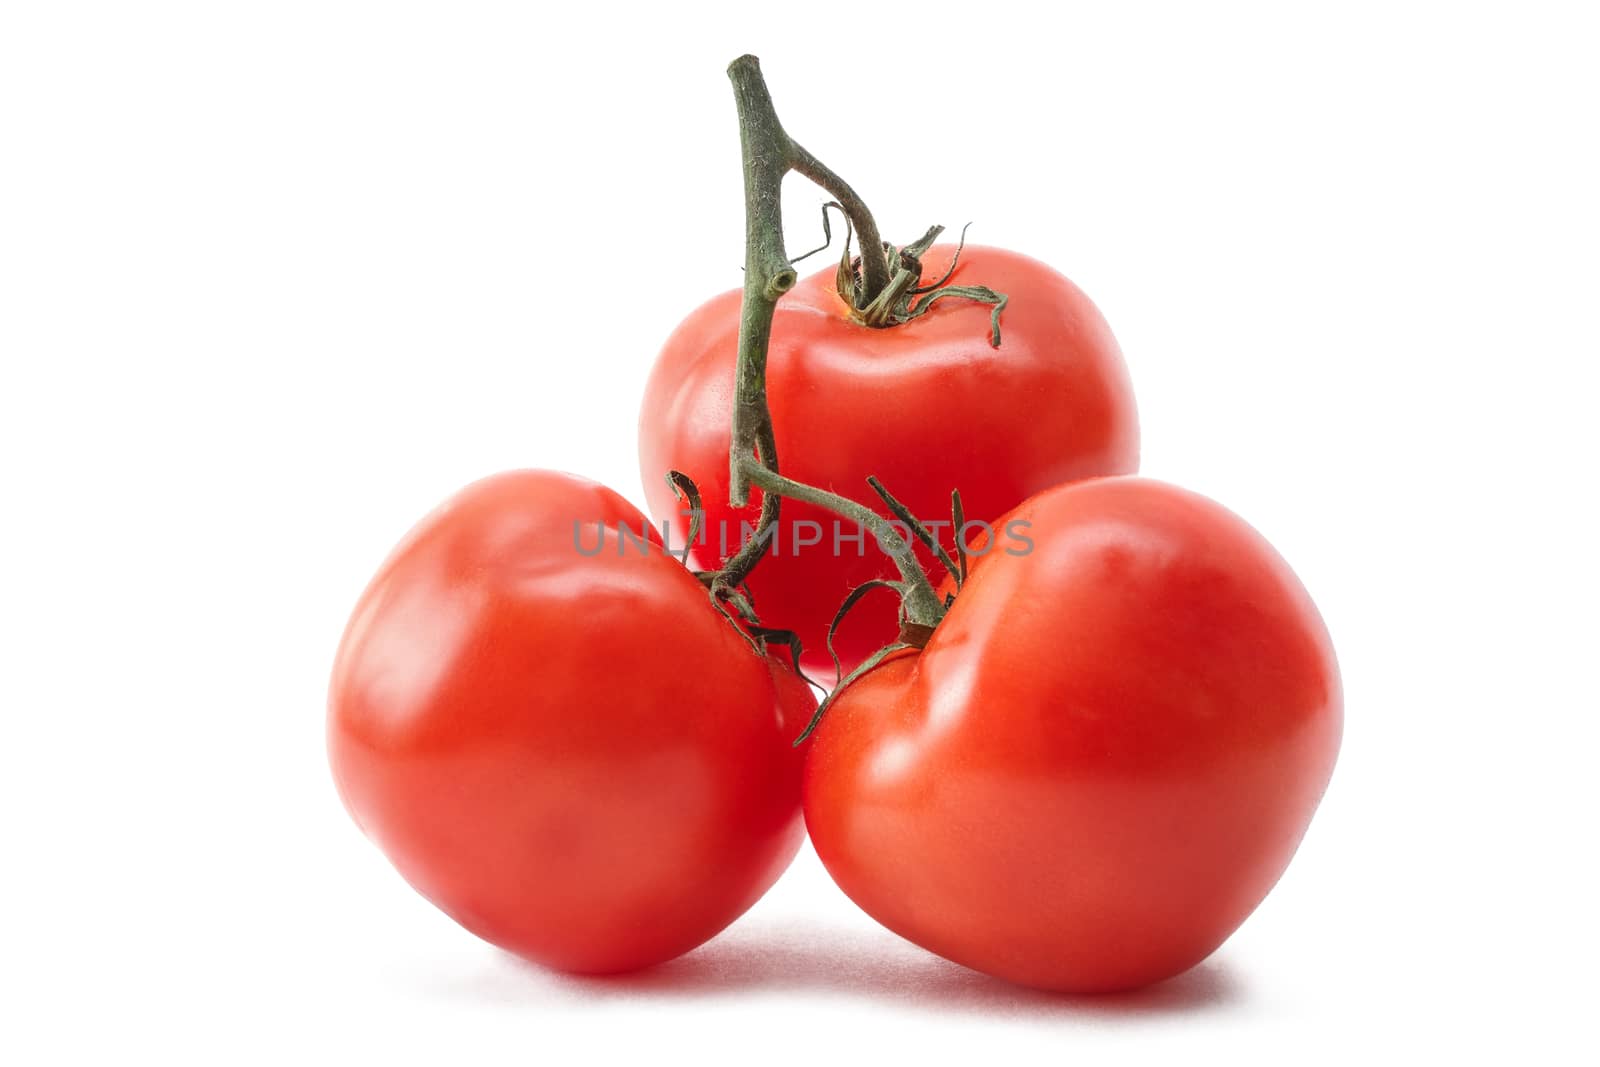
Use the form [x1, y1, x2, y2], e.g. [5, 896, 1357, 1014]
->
[717, 56, 944, 633]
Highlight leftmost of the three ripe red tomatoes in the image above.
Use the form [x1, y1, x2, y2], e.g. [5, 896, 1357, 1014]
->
[328, 470, 814, 973]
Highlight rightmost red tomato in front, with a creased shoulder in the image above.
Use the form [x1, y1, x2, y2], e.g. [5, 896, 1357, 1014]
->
[805, 478, 1342, 992]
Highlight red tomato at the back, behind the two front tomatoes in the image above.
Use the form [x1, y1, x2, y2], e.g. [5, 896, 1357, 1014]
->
[638, 245, 1139, 672]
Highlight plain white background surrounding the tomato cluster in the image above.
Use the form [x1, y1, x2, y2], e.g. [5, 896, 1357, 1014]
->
[0, 2, 1600, 1064]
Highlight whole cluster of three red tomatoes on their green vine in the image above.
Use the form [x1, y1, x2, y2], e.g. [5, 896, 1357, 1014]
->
[328, 58, 1342, 992]
